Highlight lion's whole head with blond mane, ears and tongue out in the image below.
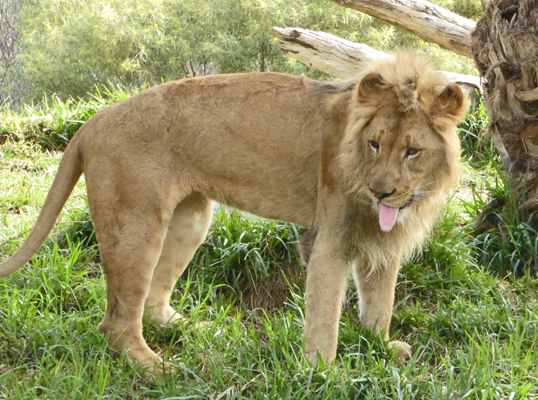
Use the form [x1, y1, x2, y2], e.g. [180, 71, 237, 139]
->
[340, 54, 469, 260]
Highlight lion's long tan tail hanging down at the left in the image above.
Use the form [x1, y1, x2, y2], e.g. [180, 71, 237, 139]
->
[0, 138, 82, 278]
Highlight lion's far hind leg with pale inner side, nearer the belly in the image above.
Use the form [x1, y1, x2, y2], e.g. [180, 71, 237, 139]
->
[144, 193, 213, 325]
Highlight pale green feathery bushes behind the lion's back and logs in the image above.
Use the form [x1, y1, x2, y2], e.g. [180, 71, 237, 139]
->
[14, 0, 474, 102]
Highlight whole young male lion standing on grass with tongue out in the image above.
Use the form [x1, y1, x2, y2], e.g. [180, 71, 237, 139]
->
[0, 54, 468, 372]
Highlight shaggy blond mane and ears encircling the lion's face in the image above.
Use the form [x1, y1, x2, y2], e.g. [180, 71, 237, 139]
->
[338, 52, 469, 271]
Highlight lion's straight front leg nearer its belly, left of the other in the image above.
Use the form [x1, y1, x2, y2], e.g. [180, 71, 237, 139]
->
[304, 236, 350, 365]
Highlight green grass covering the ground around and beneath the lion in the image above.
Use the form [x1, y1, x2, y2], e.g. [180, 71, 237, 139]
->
[0, 95, 538, 400]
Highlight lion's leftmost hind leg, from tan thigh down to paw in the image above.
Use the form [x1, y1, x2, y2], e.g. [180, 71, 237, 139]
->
[87, 180, 181, 373]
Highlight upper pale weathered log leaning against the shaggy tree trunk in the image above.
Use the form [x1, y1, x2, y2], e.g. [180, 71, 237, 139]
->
[330, 0, 476, 57]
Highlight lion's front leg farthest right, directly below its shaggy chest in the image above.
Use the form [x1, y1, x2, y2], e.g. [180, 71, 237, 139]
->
[353, 262, 412, 360]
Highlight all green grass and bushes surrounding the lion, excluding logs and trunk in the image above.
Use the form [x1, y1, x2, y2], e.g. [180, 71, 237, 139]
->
[0, 0, 538, 400]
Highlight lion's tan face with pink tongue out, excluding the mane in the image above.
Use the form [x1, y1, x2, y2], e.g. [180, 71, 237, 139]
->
[360, 107, 447, 231]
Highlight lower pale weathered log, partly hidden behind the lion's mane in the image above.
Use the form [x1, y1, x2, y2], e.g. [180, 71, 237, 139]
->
[273, 27, 480, 98]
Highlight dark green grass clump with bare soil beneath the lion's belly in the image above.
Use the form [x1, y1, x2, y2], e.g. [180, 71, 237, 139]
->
[191, 207, 304, 309]
